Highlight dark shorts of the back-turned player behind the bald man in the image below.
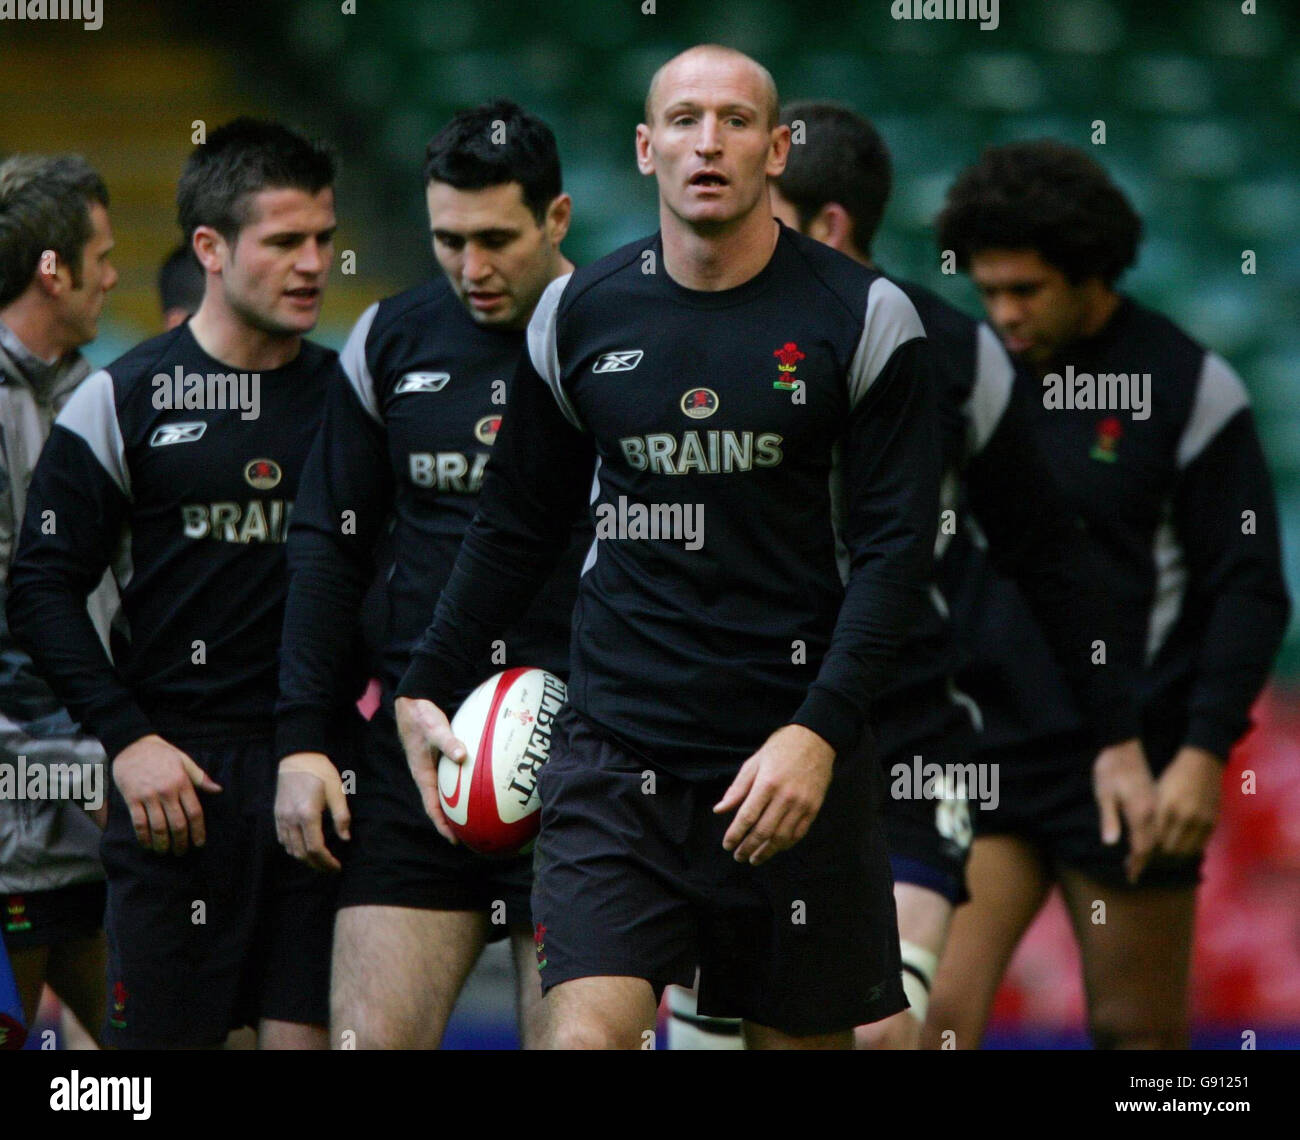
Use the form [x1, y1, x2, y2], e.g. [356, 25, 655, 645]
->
[880, 686, 979, 906]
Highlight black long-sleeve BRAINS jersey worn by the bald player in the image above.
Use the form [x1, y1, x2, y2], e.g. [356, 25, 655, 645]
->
[399, 226, 940, 779]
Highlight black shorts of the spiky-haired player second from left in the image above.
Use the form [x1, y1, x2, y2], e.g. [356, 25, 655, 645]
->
[100, 740, 337, 1048]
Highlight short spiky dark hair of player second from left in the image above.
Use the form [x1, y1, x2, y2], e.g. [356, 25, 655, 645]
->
[176, 117, 334, 242]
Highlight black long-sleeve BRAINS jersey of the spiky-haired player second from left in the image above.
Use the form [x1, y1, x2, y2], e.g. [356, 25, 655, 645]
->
[8, 325, 335, 757]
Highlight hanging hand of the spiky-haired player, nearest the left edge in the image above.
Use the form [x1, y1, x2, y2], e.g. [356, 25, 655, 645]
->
[113, 732, 221, 855]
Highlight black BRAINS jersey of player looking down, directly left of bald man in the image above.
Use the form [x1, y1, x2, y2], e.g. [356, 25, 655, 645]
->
[277, 274, 592, 755]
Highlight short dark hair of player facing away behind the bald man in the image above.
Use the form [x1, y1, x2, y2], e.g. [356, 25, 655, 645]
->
[775, 100, 893, 256]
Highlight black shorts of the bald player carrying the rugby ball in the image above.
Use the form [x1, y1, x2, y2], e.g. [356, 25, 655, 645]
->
[533, 706, 907, 1036]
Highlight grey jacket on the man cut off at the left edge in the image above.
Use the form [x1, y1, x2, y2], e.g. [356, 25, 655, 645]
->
[0, 321, 117, 894]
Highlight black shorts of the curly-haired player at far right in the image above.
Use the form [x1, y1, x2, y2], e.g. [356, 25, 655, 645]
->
[971, 733, 1203, 889]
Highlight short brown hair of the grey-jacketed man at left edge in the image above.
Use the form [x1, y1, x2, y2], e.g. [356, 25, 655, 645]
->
[0, 155, 108, 308]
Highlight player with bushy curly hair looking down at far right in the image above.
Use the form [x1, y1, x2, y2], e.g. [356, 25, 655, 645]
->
[924, 140, 1290, 1049]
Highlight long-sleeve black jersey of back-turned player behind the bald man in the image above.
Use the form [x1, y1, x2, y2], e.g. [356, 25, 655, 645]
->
[878, 281, 1139, 755]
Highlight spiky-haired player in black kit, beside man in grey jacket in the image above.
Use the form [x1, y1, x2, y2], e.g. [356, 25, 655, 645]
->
[9, 118, 335, 1048]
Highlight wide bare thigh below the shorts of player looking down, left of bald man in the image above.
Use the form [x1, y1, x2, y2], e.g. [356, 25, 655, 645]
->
[330, 906, 488, 1049]
